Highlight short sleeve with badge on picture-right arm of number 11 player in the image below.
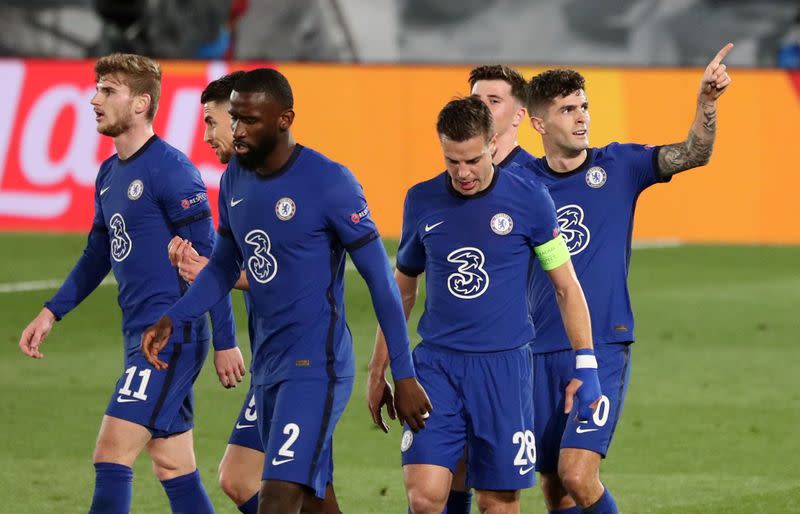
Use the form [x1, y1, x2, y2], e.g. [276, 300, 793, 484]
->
[157, 154, 211, 227]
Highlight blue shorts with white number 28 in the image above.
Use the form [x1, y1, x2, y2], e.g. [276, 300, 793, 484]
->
[400, 344, 536, 490]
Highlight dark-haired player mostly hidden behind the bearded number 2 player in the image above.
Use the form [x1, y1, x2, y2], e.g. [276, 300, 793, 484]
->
[168, 71, 340, 514]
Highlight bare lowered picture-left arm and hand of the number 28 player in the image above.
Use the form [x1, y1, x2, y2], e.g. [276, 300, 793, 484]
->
[367, 270, 418, 432]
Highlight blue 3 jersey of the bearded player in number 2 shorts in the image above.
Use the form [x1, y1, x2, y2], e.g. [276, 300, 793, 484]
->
[219, 144, 379, 385]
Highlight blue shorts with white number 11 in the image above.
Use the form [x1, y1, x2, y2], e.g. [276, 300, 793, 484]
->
[106, 332, 209, 438]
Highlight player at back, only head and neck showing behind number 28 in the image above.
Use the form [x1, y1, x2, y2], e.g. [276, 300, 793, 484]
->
[469, 64, 534, 167]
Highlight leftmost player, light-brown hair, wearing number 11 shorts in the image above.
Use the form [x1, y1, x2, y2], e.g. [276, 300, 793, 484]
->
[19, 54, 244, 514]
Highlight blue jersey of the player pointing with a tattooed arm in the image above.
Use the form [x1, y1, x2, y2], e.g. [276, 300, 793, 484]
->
[512, 143, 662, 353]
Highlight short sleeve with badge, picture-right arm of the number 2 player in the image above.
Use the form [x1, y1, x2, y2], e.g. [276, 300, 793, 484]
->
[325, 167, 380, 252]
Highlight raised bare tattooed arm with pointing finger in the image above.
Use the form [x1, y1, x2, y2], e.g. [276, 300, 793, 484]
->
[658, 43, 733, 179]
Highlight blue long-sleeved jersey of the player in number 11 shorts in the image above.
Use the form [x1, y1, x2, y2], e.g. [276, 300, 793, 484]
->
[46, 136, 235, 351]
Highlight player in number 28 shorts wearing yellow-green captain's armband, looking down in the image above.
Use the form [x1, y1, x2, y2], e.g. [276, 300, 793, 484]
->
[368, 97, 600, 514]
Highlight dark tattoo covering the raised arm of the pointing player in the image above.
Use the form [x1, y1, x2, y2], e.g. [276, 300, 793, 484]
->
[658, 104, 717, 178]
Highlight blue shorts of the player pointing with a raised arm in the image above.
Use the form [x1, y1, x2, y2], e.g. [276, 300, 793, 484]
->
[533, 343, 631, 473]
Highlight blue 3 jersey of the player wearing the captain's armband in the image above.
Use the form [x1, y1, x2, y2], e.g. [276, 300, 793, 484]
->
[397, 168, 558, 352]
